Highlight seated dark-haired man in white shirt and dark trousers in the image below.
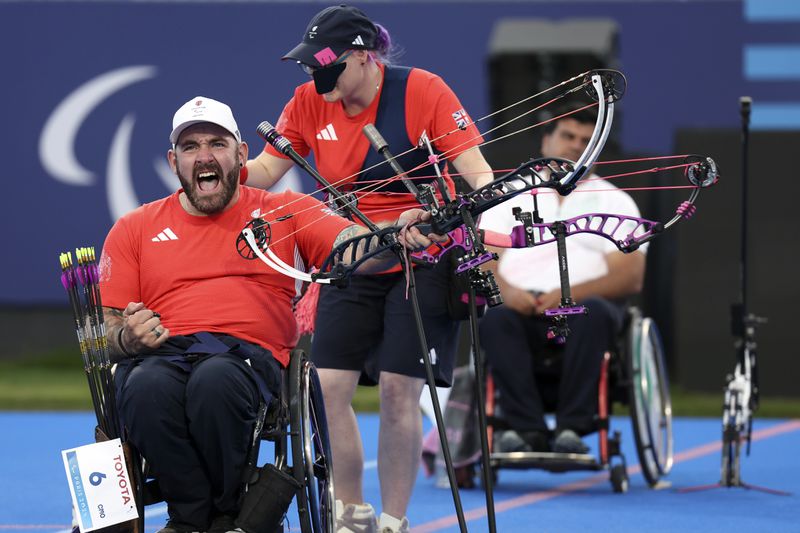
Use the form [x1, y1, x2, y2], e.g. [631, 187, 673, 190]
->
[480, 110, 646, 453]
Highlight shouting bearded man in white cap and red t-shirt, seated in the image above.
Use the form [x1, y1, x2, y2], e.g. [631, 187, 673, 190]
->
[100, 96, 438, 533]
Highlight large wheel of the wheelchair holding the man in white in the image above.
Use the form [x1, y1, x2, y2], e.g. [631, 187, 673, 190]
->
[626, 313, 673, 487]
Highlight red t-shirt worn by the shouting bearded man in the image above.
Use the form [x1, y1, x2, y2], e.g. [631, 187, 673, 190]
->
[100, 186, 352, 366]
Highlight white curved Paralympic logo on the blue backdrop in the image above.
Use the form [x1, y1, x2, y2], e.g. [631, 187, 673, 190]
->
[39, 65, 302, 220]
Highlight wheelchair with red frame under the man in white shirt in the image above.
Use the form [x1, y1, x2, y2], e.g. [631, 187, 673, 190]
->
[457, 307, 673, 493]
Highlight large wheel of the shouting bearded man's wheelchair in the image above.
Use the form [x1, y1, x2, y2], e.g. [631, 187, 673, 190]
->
[289, 352, 336, 533]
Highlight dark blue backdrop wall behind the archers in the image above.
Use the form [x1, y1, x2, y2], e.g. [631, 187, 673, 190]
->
[0, 1, 798, 304]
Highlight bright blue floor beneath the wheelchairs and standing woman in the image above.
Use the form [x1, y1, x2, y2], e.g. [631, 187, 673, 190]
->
[0, 412, 800, 533]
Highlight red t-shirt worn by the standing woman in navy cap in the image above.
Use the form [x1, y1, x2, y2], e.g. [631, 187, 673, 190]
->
[264, 63, 483, 221]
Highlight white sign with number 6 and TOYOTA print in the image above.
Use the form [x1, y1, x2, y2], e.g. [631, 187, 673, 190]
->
[61, 439, 139, 531]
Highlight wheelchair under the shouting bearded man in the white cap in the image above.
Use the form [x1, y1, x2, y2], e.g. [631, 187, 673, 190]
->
[124, 349, 336, 533]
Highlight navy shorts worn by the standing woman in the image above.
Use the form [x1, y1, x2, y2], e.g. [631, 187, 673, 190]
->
[311, 261, 459, 386]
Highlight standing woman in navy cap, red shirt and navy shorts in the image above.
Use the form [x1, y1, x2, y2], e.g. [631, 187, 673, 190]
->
[247, 5, 492, 532]
